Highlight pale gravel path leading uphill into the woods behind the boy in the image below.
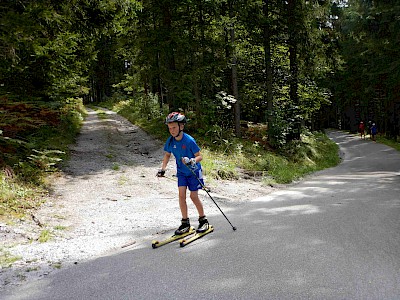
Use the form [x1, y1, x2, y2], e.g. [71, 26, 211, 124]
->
[0, 109, 273, 291]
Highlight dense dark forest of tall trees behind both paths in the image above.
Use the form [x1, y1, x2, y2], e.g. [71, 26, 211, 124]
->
[0, 0, 400, 183]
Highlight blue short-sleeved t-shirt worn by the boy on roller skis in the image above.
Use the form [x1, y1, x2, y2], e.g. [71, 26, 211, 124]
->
[164, 133, 201, 176]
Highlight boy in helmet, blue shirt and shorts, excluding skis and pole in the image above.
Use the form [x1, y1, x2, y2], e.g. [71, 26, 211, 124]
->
[157, 112, 209, 235]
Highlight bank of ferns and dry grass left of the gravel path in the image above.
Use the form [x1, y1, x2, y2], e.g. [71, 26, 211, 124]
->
[0, 98, 86, 223]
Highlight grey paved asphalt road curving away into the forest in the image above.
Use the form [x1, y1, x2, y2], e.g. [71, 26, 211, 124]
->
[0, 132, 400, 300]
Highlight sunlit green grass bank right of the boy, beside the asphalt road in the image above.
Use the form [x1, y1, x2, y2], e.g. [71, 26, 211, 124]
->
[203, 132, 340, 184]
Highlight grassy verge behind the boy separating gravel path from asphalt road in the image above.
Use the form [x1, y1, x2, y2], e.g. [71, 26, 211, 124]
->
[100, 99, 340, 185]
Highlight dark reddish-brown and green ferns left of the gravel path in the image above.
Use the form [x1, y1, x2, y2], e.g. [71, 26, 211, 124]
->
[0, 98, 84, 183]
